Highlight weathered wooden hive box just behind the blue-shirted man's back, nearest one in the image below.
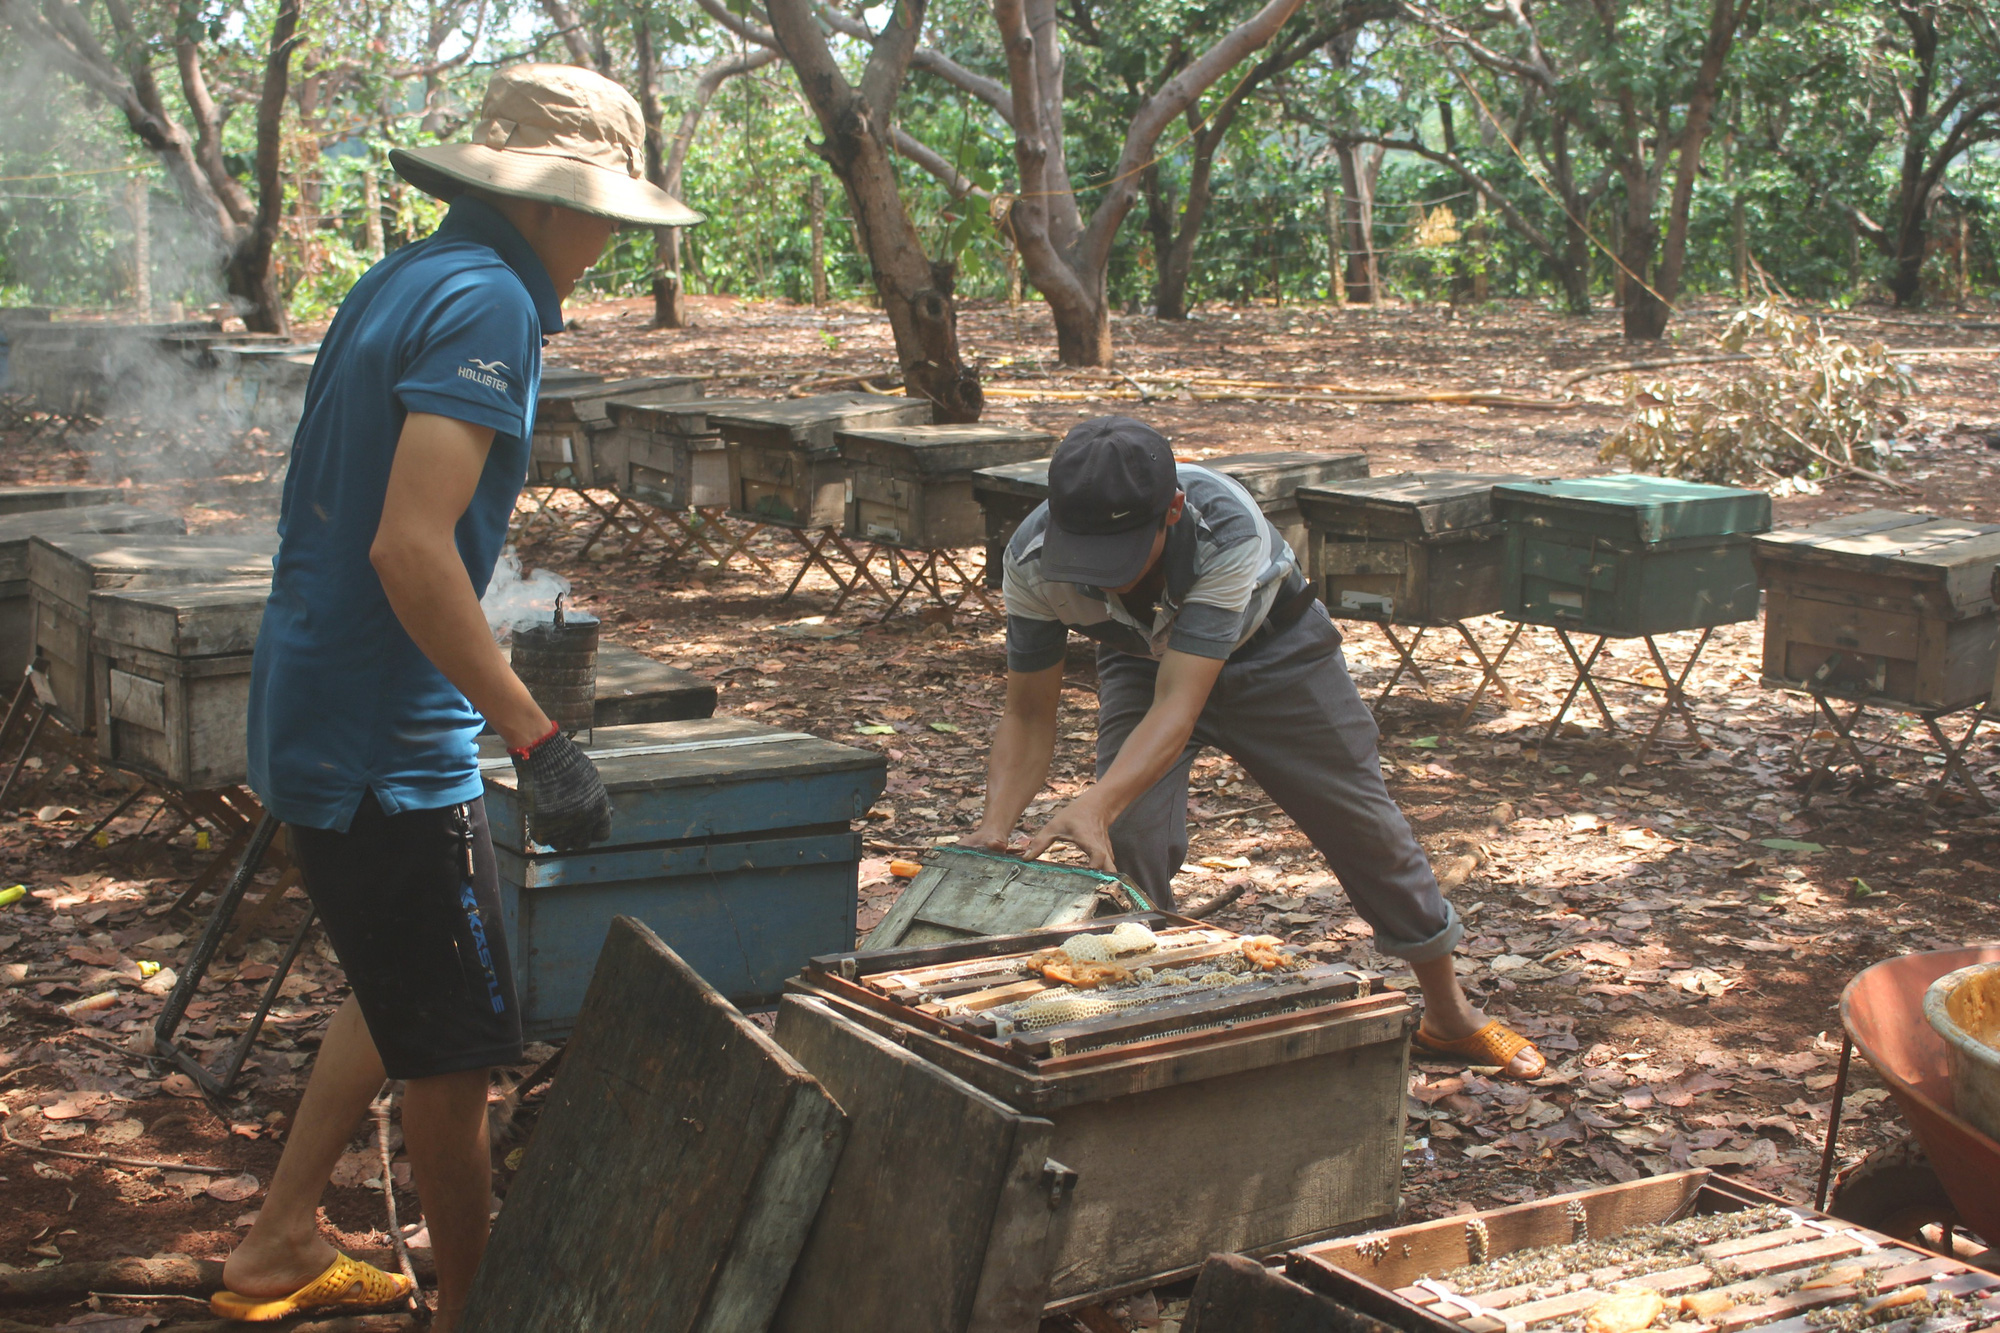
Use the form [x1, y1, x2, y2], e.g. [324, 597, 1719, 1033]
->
[90, 578, 270, 791]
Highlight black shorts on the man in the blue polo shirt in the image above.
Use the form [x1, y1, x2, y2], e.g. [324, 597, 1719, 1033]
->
[292, 795, 522, 1079]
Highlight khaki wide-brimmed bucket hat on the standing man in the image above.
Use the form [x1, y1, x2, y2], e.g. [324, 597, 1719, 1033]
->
[388, 64, 702, 226]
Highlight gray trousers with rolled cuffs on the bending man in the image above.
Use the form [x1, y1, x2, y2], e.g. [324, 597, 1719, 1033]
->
[1098, 602, 1464, 963]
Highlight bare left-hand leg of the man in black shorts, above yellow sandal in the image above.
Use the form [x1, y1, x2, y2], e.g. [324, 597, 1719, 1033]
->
[222, 997, 384, 1301]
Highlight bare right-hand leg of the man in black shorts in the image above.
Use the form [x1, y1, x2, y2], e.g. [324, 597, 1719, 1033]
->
[402, 1069, 492, 1333]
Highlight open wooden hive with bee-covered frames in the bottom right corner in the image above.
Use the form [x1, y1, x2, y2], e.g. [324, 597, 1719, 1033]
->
[1280, 1171, 2000, 1333]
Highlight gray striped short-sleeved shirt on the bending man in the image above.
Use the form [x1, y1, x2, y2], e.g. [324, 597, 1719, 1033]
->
[1004, 462, 1298, 671]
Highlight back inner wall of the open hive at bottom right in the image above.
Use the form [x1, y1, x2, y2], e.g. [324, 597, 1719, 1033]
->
[1300, 1171, 1708, 1289]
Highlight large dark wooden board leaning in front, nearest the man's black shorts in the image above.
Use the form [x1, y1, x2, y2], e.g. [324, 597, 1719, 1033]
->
[460, 919, 848, 1333]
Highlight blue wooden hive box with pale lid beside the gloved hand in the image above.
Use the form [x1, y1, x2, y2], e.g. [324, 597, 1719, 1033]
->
[480, 717, 888, 1039]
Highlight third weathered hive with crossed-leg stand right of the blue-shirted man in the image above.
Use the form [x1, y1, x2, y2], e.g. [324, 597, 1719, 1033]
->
[710, 392, 930, 604]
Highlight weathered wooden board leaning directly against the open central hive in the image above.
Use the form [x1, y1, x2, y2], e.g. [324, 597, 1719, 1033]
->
[772, 995, 1060, 1333]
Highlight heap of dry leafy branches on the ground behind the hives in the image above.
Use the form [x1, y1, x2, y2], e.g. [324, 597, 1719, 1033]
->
[1598, 302, 1912, 486]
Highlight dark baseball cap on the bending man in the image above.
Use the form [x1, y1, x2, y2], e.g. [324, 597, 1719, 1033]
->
[1042, 416, 1180, 588]
